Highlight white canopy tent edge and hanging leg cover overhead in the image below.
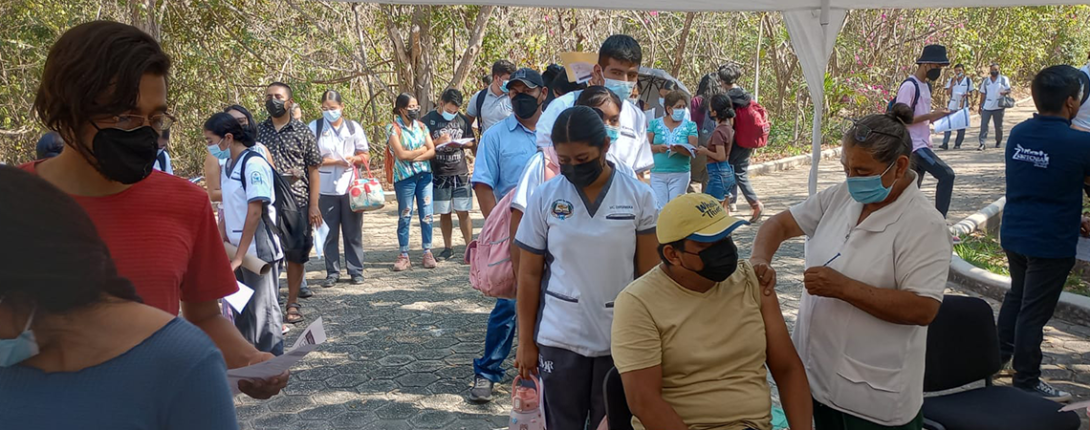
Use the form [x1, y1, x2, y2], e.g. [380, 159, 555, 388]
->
[343, 0, 1087, 194]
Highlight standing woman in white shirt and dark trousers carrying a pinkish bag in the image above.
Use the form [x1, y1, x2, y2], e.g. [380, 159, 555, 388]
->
[309, 89, 370, 288]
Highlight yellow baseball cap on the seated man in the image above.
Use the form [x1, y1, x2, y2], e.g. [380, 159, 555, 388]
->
[655, 193, 749, 243]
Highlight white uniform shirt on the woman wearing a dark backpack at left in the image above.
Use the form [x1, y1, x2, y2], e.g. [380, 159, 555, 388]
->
[219, 150, 282, 258]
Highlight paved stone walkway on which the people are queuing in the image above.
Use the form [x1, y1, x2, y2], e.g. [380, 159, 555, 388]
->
[237, 100, 1090, 430]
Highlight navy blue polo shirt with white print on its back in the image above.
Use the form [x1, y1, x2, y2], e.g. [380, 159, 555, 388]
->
[1000, 115, 1090, 259]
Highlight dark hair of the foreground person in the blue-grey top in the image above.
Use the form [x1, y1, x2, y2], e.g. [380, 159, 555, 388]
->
[0, 166, 143, 313]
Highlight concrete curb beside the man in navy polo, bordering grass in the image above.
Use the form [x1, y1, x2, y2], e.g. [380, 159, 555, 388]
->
[949, 198, 1090, 325]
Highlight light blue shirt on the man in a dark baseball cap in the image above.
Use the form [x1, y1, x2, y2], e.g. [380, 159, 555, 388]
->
[471, 115, 537, 201]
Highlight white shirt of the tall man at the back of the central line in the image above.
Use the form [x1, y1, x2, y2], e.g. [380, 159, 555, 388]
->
[535, 89, 655, 172]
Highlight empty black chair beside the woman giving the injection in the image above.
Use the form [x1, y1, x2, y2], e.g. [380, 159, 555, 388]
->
[923, 296, 1080, 430]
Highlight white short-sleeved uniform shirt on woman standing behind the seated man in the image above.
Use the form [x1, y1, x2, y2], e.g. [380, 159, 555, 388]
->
[514, 164, 657, 357]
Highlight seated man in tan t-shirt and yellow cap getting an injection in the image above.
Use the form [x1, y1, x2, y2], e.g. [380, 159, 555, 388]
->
[611, 194, 812, 430]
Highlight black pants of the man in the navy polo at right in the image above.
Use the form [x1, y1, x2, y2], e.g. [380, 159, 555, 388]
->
[998, 251, 1075, 389]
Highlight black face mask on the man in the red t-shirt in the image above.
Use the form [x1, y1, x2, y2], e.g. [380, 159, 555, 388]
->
[92, 126, 159, 186]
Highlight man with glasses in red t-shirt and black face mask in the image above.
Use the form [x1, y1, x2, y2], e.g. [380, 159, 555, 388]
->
[22, 21, 288, 398]
